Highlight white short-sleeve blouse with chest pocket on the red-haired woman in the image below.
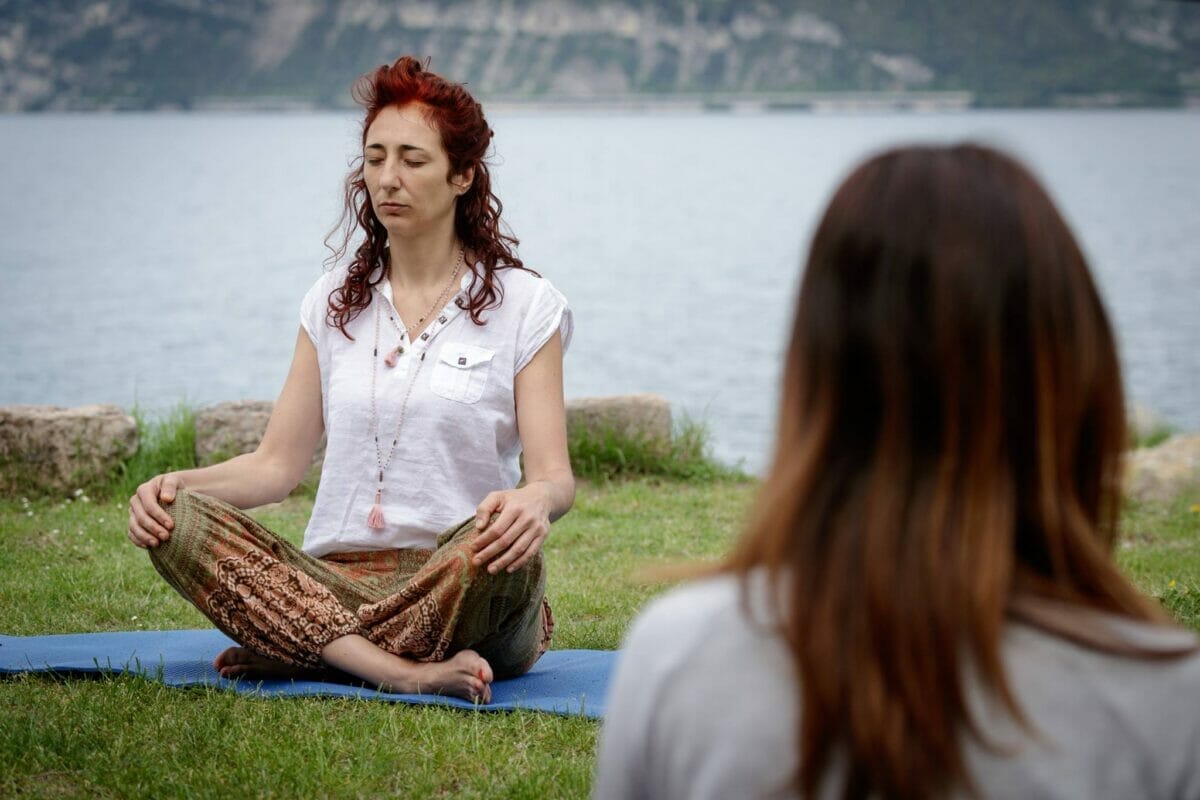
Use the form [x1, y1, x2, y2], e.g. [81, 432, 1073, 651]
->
[300, 266, 572, 557]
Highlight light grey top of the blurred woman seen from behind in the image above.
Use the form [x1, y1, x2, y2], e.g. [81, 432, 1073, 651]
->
[594, 577, 1200, 800]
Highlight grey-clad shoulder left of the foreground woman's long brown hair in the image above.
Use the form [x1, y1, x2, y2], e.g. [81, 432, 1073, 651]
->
[596, 573, 797, 798]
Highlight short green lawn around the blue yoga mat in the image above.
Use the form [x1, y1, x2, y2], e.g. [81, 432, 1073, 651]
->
[0, 417, 1200, 798]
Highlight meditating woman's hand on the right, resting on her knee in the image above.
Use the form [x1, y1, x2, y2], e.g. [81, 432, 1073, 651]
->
[474, 481, 552, 575]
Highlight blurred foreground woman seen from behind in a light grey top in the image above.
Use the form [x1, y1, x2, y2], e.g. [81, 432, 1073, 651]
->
[595, 145, 1200, 800]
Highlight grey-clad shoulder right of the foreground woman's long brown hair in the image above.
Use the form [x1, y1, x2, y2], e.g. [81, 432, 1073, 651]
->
[971, 612, 1200, 798]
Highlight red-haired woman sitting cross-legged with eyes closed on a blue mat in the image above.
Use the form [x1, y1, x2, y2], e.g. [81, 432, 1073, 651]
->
[128, 58, 575, 702]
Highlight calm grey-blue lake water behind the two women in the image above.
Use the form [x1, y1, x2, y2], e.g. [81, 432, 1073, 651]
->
[0, 112, 1200, 469]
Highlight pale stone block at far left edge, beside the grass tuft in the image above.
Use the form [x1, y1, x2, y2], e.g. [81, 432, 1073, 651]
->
[0, 405, 138, 494]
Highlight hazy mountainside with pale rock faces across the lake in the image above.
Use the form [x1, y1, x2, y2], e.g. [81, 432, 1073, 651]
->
[0, 0, 1200, 112]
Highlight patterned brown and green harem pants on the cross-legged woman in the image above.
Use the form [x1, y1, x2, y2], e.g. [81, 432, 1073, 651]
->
[150, 492, 554, 679]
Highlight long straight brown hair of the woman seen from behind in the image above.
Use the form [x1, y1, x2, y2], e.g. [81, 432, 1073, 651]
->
[726, 145, 1176, 798]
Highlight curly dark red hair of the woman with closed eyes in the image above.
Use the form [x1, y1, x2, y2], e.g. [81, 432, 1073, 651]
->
[325, 55, 533, 338]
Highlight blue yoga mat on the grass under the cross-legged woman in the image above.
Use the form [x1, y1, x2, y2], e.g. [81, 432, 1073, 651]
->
[0, 630, 617, 718]
